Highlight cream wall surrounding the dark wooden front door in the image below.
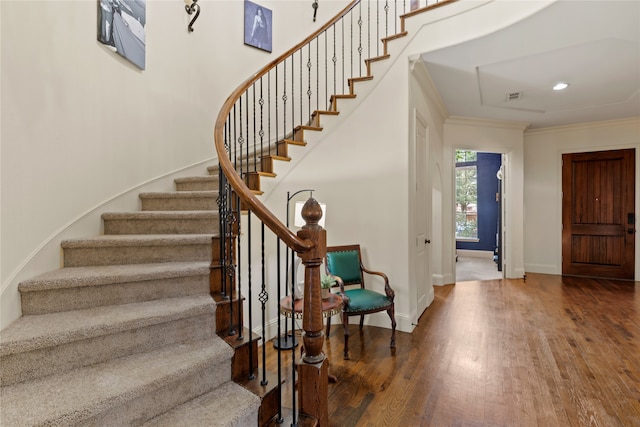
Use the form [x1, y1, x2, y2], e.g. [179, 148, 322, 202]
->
[524, 118, 640, 279]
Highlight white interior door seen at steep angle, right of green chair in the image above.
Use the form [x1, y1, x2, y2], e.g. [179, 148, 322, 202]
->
[415, 114, 433, 320]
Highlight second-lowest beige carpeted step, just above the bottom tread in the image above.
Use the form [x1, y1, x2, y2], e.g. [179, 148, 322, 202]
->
[0, 339, 233, 426]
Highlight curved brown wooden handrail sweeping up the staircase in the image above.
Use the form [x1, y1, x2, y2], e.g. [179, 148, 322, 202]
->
[214, 0, 360, 252]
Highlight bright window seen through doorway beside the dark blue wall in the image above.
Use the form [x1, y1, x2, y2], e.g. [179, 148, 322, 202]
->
[456, 150, 478, 240]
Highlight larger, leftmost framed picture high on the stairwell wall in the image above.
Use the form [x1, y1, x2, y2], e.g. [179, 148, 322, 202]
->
[98, 0, 147, 70]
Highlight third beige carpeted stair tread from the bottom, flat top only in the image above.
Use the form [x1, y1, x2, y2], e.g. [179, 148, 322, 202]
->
[0, 295, 215, 356]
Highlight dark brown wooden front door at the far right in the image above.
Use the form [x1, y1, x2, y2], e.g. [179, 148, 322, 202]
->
[562, 149, 635, 280]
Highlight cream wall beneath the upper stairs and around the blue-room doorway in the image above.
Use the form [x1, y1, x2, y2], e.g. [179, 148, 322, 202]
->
[249, 1, 548, 331]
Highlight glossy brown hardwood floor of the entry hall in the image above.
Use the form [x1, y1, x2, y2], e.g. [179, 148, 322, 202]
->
[267, 274, 640, 427]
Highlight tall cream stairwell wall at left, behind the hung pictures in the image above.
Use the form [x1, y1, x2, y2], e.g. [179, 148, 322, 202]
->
[0, 0, 348, 328]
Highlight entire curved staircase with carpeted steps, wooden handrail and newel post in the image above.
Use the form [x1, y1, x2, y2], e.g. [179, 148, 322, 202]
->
[0, 0, 455, 427]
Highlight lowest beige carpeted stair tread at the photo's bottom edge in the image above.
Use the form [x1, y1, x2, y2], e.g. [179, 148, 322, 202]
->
[143, 381, 260, 427]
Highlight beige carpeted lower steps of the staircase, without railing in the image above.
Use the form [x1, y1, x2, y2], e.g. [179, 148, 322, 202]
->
[0, 172, 260, 427]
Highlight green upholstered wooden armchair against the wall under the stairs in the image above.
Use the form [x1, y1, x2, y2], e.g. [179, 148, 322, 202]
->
[325, 245, 396, 359]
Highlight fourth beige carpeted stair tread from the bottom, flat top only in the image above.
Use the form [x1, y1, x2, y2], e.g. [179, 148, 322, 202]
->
[18, 261, 211, 292]
